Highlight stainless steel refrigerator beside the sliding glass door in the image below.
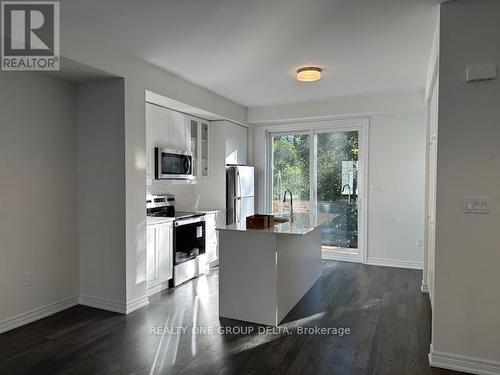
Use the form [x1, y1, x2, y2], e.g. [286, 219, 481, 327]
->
[226, 165, 255, 224]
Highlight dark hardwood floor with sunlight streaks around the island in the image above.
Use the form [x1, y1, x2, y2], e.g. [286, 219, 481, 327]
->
[0, 261, 464, 375]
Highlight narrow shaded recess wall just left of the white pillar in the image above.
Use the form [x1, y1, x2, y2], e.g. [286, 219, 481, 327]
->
[74, 79, 127, 310]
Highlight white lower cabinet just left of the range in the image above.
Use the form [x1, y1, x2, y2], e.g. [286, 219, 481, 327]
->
[146, 222, 173, 295]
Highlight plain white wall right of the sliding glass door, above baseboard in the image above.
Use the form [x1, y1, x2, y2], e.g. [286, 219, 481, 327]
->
[368, 109, 426, 268]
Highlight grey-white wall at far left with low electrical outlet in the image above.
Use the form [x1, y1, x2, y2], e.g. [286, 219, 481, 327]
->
[0, 72, 78, 331]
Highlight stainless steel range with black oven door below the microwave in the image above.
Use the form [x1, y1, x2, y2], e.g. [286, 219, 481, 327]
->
[147, 196, 208, 286]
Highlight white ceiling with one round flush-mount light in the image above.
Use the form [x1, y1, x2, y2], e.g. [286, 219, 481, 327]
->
[61, 0, 438, 107]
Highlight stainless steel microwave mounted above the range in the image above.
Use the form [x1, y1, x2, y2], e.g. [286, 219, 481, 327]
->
[155, 147, 194, 180]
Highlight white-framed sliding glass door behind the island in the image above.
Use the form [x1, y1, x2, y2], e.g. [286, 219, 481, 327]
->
[269, 122, 364, 262]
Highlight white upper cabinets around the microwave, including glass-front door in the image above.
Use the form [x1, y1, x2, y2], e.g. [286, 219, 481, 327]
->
[146, 102, 210, 181]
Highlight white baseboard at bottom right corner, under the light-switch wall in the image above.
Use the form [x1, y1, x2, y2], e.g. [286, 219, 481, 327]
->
[429, 344, 500, 375]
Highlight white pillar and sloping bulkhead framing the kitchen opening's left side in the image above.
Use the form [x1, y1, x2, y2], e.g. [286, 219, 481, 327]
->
[61, 30, 246, 303]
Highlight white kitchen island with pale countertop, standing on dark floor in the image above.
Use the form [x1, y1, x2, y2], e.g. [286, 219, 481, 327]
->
[217, 214, 336, 326]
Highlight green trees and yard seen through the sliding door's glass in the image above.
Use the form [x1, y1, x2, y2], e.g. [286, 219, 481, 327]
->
[273, 131, 359, 248]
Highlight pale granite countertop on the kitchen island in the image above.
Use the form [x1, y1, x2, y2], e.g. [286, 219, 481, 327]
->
[217, 212, 339, 235]
